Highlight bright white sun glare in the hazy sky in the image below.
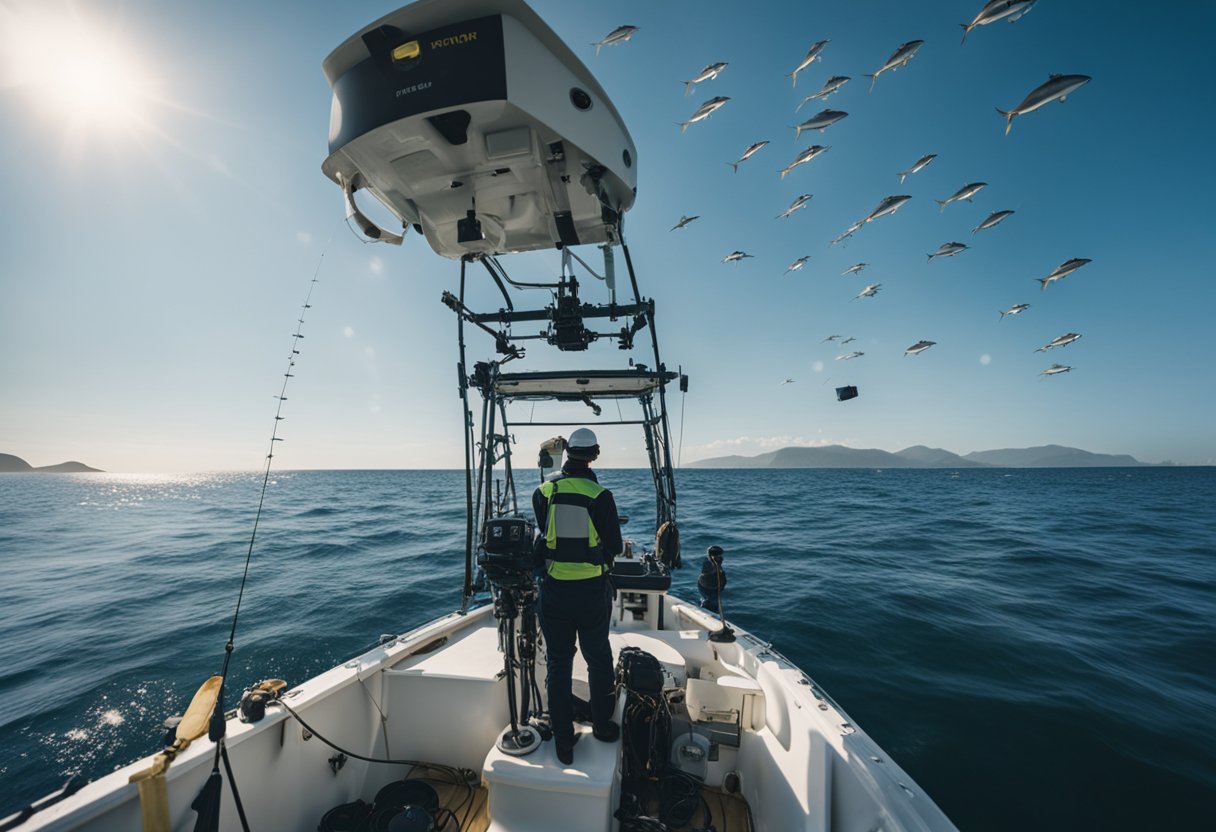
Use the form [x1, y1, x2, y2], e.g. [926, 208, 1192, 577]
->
[0, 2, 158, 140]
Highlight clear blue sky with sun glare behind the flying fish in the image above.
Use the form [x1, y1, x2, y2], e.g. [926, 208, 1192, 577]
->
[0, 0, 1216, 472]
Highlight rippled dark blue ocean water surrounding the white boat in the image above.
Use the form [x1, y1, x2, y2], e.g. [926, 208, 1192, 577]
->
[0, 468, 1216, 831]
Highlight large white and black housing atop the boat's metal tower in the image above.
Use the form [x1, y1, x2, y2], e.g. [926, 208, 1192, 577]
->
[321, 0, 637, 258]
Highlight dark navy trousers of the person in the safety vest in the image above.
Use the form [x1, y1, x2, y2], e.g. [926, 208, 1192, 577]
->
[540, 577, 617, 748]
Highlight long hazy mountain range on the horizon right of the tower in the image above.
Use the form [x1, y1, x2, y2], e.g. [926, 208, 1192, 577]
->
[688, 445, 1152, 468]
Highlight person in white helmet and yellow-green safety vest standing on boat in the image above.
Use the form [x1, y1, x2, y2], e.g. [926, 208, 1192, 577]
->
[533, 428, 624, 765]
